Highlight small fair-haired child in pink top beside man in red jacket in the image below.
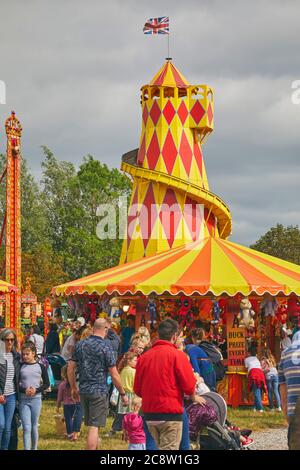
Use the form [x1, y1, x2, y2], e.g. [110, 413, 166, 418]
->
[123, 396, 146, 450]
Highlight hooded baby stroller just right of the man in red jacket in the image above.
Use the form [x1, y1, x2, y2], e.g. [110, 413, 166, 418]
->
[187, 392, 251, 450]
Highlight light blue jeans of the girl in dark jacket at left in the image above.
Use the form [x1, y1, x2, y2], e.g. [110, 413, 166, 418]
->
[19, 395, 42, 450]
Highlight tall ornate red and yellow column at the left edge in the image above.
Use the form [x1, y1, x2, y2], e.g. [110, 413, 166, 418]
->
[5, 111, 22, 336]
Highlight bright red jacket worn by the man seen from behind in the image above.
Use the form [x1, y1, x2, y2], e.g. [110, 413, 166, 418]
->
[134, 340, 196, 420]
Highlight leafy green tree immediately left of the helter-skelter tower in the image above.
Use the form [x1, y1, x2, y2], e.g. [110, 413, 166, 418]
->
[42, 147, 131, 279]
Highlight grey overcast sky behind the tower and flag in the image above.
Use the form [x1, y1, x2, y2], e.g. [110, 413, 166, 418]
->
[0, 0, 300, 248]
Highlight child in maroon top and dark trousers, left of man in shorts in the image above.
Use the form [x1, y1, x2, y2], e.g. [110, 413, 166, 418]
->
[56, 366, 82, 441]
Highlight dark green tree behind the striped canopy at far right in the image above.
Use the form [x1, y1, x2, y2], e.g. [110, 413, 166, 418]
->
[250, 224, 300, 264]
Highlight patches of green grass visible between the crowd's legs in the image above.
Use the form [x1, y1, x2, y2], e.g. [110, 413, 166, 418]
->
[19, 400, 286, 450]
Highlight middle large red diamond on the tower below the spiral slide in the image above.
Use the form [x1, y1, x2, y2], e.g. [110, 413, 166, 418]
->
[159, 189, 182, 248]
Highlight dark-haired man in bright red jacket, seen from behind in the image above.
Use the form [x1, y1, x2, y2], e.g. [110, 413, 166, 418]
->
[134, 319, 196, 450]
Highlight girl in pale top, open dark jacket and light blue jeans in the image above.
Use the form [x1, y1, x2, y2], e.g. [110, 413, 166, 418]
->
[19, 342, 50, 450]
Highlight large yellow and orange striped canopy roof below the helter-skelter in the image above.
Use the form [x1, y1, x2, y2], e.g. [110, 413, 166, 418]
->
[52, 237, 300, 296]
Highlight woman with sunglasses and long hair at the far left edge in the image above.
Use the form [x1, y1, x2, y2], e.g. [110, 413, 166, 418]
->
[0, 328, 20, 450]
